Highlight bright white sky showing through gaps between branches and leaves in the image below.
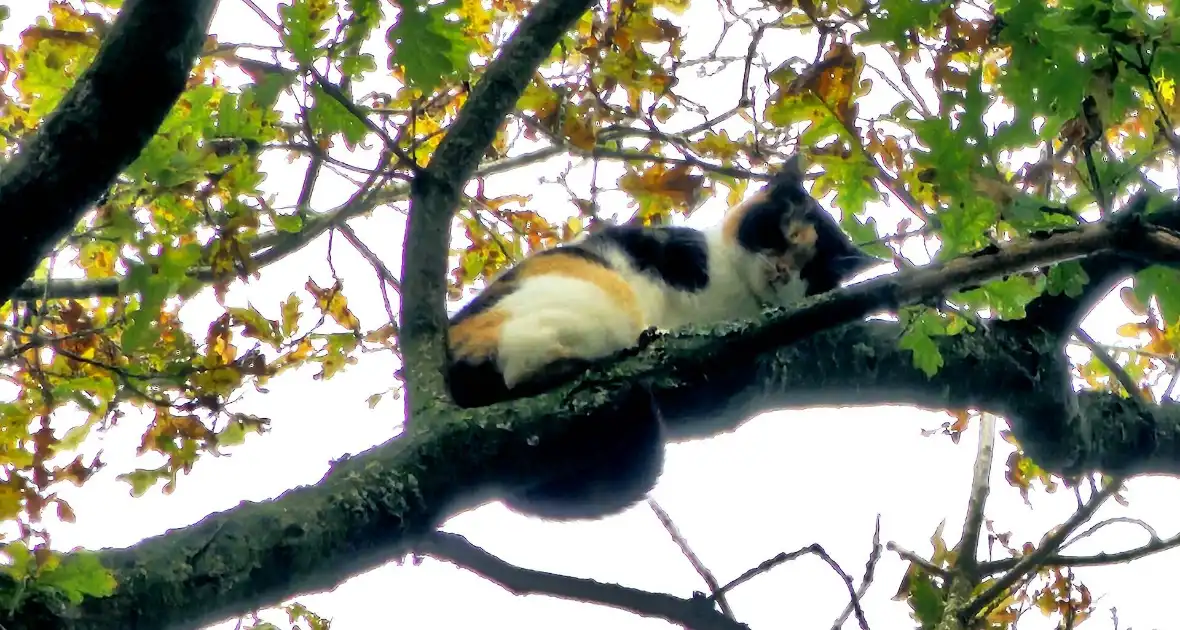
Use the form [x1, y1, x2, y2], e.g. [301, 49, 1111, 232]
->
[4, 0, 1180, 630]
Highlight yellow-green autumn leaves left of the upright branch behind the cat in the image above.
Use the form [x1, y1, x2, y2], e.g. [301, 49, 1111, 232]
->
[0, 2, 410, 579]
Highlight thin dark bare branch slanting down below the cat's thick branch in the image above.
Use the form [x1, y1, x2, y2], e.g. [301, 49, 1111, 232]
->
[415, 532, 749, 630]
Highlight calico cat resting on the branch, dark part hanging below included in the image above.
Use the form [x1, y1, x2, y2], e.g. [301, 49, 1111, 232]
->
[447, 158, 883, 520]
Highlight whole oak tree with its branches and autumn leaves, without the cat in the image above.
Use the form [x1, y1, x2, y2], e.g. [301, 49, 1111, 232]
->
[0, 0, 1180, 630]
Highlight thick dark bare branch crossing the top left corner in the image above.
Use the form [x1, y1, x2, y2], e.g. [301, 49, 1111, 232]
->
[0, 0, 217, 300]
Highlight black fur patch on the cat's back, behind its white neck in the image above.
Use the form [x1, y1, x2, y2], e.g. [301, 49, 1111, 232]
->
[583, 224, 709, 291]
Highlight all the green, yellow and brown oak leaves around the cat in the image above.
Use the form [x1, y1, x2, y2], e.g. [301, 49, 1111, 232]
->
[0, 0, 1180, 628]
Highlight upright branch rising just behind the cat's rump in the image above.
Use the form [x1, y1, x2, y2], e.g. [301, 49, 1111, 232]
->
[399, 0, 594, 410]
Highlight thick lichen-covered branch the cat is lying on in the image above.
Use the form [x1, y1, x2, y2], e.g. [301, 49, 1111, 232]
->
[11, 211, 1180, 630]
